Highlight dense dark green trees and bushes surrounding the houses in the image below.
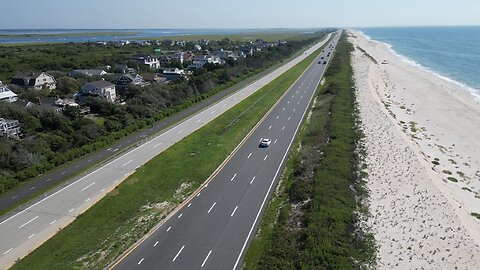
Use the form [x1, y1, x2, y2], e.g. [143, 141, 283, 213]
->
[0, 33, 323, 193]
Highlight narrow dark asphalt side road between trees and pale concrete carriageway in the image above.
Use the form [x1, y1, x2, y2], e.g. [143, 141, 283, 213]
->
[0, 33, 326, 213]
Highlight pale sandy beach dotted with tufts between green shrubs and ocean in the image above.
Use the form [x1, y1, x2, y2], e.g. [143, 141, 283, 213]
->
[350, 31, 480, 269]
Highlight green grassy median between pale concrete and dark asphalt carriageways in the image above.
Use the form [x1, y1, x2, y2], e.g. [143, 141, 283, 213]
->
[13, 42, 321, 269]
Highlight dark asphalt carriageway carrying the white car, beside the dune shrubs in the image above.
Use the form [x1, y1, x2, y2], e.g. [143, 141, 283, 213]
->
[112, 30, 340, 269]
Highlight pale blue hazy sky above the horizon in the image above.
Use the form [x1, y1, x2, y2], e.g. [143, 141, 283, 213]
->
[0, 0, 480, 29]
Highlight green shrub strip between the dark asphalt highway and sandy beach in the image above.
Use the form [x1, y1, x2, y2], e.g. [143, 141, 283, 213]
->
[250, 35, 375, 269]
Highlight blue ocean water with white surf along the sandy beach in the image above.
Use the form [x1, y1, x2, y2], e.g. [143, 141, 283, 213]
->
[358, 26, 480, 97]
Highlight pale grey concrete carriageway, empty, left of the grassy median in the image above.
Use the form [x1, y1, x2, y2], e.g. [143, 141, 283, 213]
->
[0, 32, 330, 269]
